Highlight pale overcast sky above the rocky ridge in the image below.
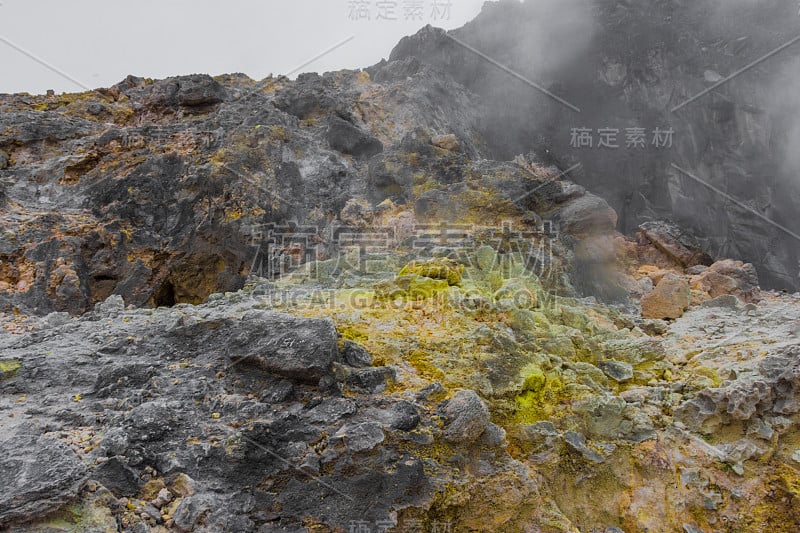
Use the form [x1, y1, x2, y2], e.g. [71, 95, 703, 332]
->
[0, 0, 484, 94]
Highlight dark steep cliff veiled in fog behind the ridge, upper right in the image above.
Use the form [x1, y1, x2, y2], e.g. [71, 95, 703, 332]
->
[392, 0, 800, 288]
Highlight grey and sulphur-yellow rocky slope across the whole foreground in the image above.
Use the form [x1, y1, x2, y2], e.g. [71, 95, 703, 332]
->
[0, 247, 800, 532]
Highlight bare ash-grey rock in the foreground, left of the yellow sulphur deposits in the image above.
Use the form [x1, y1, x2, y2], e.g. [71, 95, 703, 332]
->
[0, 297, 536, 532]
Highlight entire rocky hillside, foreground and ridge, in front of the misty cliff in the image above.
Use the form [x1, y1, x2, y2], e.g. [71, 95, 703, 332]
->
[0, 3, 800, 533]
